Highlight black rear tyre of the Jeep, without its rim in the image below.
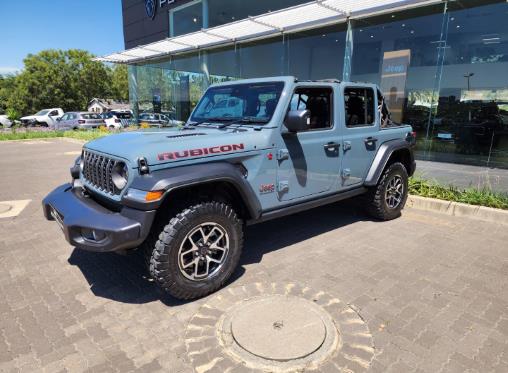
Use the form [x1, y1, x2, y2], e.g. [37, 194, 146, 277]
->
[366, 162, 408, 220]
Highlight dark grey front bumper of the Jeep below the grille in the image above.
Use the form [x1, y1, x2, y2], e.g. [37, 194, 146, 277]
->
[42, 184, 156, 252]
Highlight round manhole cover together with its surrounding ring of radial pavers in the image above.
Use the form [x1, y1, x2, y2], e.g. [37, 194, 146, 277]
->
[185, 283, 374, 373]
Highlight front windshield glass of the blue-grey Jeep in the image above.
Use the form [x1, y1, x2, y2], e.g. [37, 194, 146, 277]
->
[191, 82, 284, 123]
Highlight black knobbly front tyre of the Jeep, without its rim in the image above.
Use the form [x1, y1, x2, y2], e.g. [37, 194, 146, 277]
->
[150, 201, 243, 300]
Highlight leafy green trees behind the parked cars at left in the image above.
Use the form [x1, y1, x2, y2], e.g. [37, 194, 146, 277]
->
[0, 49, 128, 115]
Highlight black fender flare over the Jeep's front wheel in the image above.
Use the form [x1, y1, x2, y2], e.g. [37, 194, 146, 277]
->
[122, 162, 261, 219]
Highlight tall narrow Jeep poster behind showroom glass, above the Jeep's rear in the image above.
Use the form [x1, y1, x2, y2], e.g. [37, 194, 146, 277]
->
[381, 49, 411, 122]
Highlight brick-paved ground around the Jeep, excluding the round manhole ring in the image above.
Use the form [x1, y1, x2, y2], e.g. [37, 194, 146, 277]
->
[0, 140, 508, 372]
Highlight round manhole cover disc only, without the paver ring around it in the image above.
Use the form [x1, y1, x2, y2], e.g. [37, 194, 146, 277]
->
[229, 295, 337, 361]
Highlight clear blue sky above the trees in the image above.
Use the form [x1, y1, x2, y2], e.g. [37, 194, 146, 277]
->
[0, 0, 124, 74]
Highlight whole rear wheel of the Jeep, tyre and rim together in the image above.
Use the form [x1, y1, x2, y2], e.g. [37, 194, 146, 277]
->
[366, 162, 408, 220]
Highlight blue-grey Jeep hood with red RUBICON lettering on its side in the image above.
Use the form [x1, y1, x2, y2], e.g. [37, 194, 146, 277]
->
[85, 127, 265, 167]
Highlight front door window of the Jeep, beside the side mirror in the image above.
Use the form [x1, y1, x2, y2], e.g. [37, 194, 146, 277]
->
[289, 88, 332, 130]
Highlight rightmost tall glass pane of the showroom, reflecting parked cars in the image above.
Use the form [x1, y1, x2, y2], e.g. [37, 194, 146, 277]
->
[430, 2, 508, 167]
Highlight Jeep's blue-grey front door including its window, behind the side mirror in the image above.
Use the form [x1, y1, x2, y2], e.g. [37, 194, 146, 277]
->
[277, 84, 340, 201]
